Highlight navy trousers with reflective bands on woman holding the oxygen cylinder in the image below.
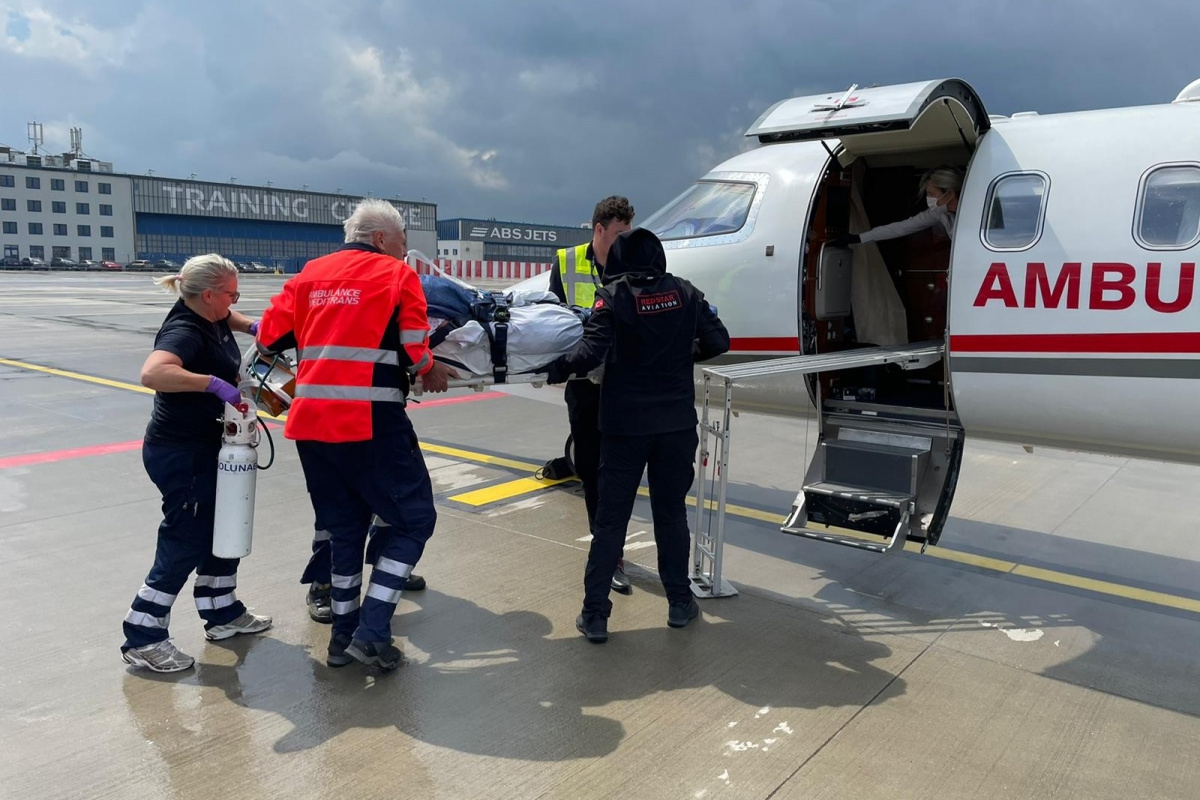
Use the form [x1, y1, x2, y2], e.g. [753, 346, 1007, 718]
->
[121, 444, 246, 651]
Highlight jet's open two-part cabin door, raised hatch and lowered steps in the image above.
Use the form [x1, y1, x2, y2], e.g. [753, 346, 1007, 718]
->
[746, 79, 989, 553]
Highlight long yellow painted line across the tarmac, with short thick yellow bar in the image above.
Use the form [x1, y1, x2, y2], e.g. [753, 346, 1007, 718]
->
[0, 357, 1200, 614]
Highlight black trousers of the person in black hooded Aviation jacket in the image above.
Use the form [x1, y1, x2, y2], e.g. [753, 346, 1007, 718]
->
[583, 428, 700, 616]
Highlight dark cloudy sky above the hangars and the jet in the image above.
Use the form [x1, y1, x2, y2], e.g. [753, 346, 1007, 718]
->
[0, 0, 1200, 224]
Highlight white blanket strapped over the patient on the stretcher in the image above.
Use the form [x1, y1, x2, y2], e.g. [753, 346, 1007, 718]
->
[430, 303, 583, 375]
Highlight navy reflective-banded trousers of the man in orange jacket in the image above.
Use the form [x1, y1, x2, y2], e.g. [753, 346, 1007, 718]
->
[296, 415, 437, 642]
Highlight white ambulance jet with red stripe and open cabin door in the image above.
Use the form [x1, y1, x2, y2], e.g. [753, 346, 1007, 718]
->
[511, 79, 1200, 552]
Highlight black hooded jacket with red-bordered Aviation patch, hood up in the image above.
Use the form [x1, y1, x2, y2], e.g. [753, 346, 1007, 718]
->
[550, 228, 730, 437]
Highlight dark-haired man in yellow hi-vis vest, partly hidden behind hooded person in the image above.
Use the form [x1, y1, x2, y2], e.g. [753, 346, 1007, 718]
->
[550, 196, 634, 594]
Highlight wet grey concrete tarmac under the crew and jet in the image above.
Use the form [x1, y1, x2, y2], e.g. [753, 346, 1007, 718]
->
[7, 272, 1200, 800]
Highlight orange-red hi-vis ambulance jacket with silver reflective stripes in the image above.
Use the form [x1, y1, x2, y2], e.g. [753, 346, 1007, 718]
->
[257, 245, 433, 443]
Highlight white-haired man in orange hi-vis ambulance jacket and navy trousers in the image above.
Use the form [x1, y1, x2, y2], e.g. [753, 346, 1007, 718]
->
[257, 200, 458, 670]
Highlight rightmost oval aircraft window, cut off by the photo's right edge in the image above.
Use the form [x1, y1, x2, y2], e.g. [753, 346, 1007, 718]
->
[1134, 164, 1200, 249]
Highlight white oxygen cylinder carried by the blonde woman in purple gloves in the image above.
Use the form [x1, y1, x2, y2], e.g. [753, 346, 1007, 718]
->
[212, 399, 258, 559]
